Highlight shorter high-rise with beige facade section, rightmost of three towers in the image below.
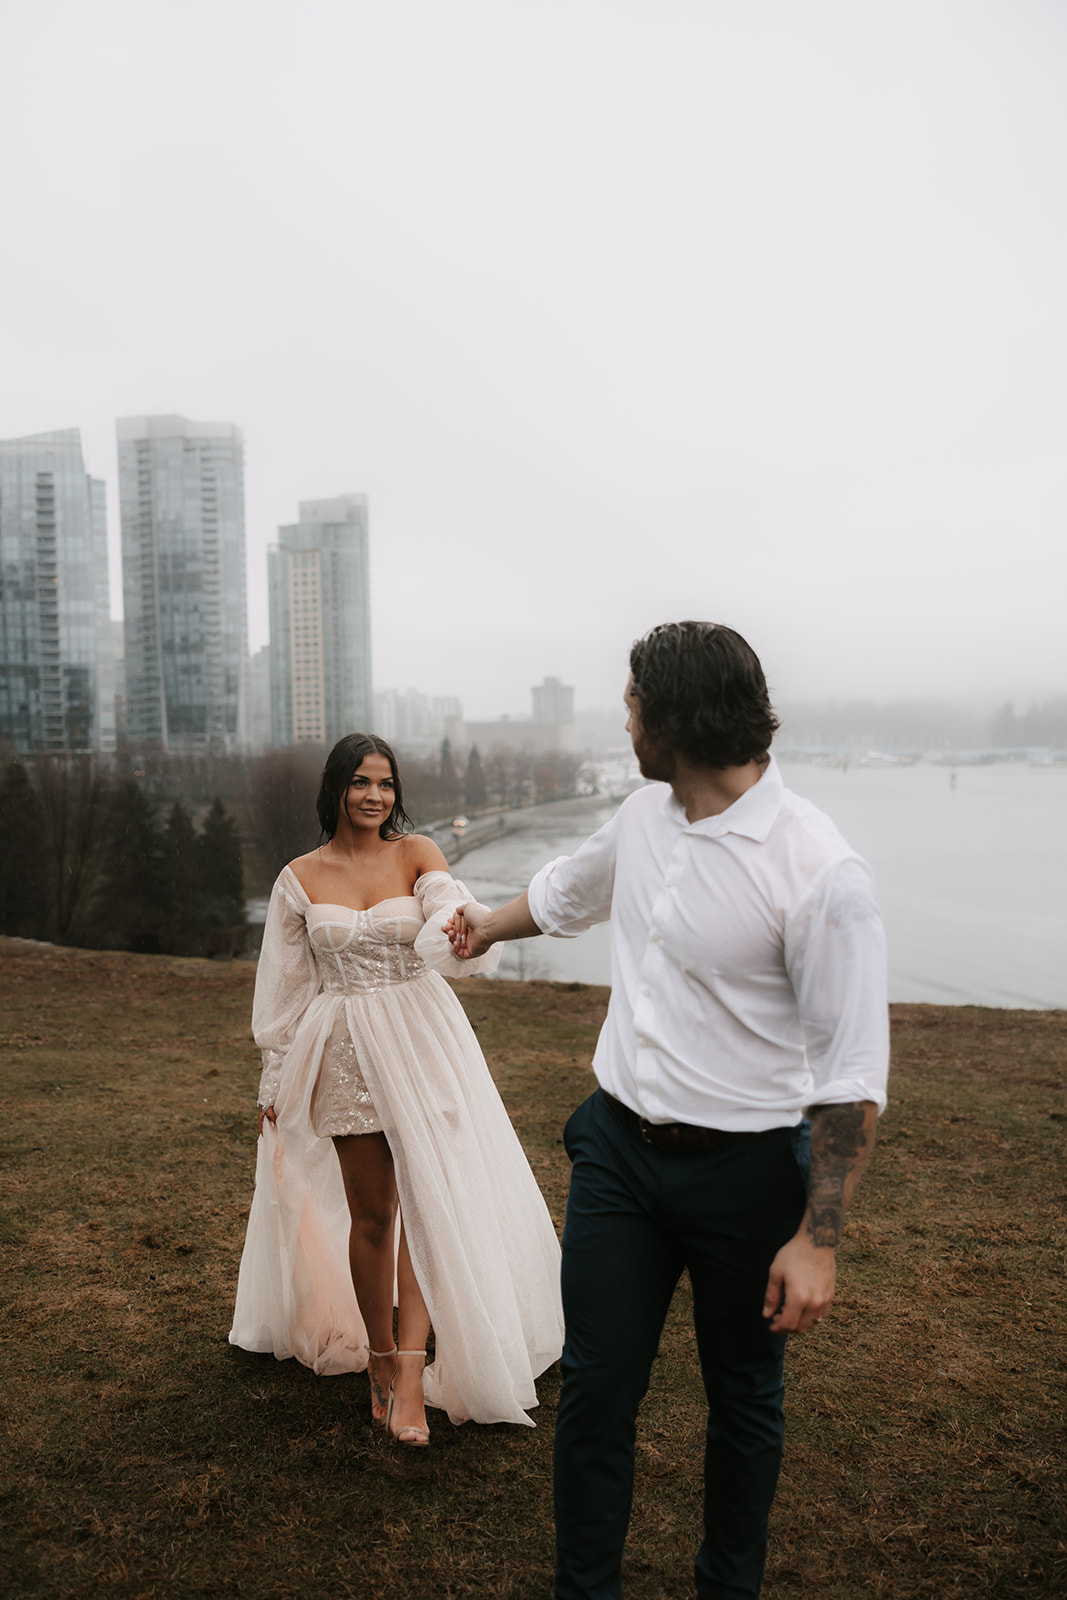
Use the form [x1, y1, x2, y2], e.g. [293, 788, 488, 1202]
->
[267, 494, 371, 747]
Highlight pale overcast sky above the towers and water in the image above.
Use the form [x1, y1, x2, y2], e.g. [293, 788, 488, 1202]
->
[0, 0, 1067, 717]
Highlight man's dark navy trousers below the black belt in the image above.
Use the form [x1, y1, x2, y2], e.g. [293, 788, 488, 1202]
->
[555, 1091, 805, 1600]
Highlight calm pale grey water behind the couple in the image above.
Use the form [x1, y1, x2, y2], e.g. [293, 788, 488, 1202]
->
[454, 763, 1067, 1008]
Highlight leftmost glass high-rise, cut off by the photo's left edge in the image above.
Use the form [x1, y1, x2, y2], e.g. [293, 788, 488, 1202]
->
[0, 427, 115, 752]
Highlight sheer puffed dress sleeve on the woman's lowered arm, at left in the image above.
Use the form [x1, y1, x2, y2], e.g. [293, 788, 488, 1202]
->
[251, 867, 318, 1106]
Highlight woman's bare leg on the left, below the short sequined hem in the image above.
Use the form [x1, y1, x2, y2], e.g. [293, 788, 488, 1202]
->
[333, 1133, 399, 1422]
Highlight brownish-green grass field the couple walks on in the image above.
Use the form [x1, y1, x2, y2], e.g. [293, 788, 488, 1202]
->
[0, 941, 1067, 1600]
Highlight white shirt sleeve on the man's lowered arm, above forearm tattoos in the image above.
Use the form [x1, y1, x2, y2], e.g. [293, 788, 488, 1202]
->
[785, 856, 889, 1112]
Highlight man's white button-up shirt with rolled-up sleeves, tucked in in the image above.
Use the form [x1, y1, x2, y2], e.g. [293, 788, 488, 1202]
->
[530, 758, 889, 1131]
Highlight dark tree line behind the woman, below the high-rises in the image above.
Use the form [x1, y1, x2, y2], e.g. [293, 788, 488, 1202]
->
[0, 739, 579, 955]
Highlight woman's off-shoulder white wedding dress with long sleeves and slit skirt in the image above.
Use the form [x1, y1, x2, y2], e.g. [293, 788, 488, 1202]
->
[230, 867, 563, 1424]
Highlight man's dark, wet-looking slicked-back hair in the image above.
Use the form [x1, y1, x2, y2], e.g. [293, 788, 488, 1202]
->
[630, 622, 777, 770]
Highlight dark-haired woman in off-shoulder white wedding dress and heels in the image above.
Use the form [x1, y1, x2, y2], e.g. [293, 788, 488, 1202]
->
[230, 734, 563, 1445]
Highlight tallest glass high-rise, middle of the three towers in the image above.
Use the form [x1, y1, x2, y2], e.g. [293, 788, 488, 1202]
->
[117, 416, 248, 754]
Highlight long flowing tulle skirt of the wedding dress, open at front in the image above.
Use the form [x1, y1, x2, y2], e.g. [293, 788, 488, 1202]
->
[230, 971, 563, 1422]
